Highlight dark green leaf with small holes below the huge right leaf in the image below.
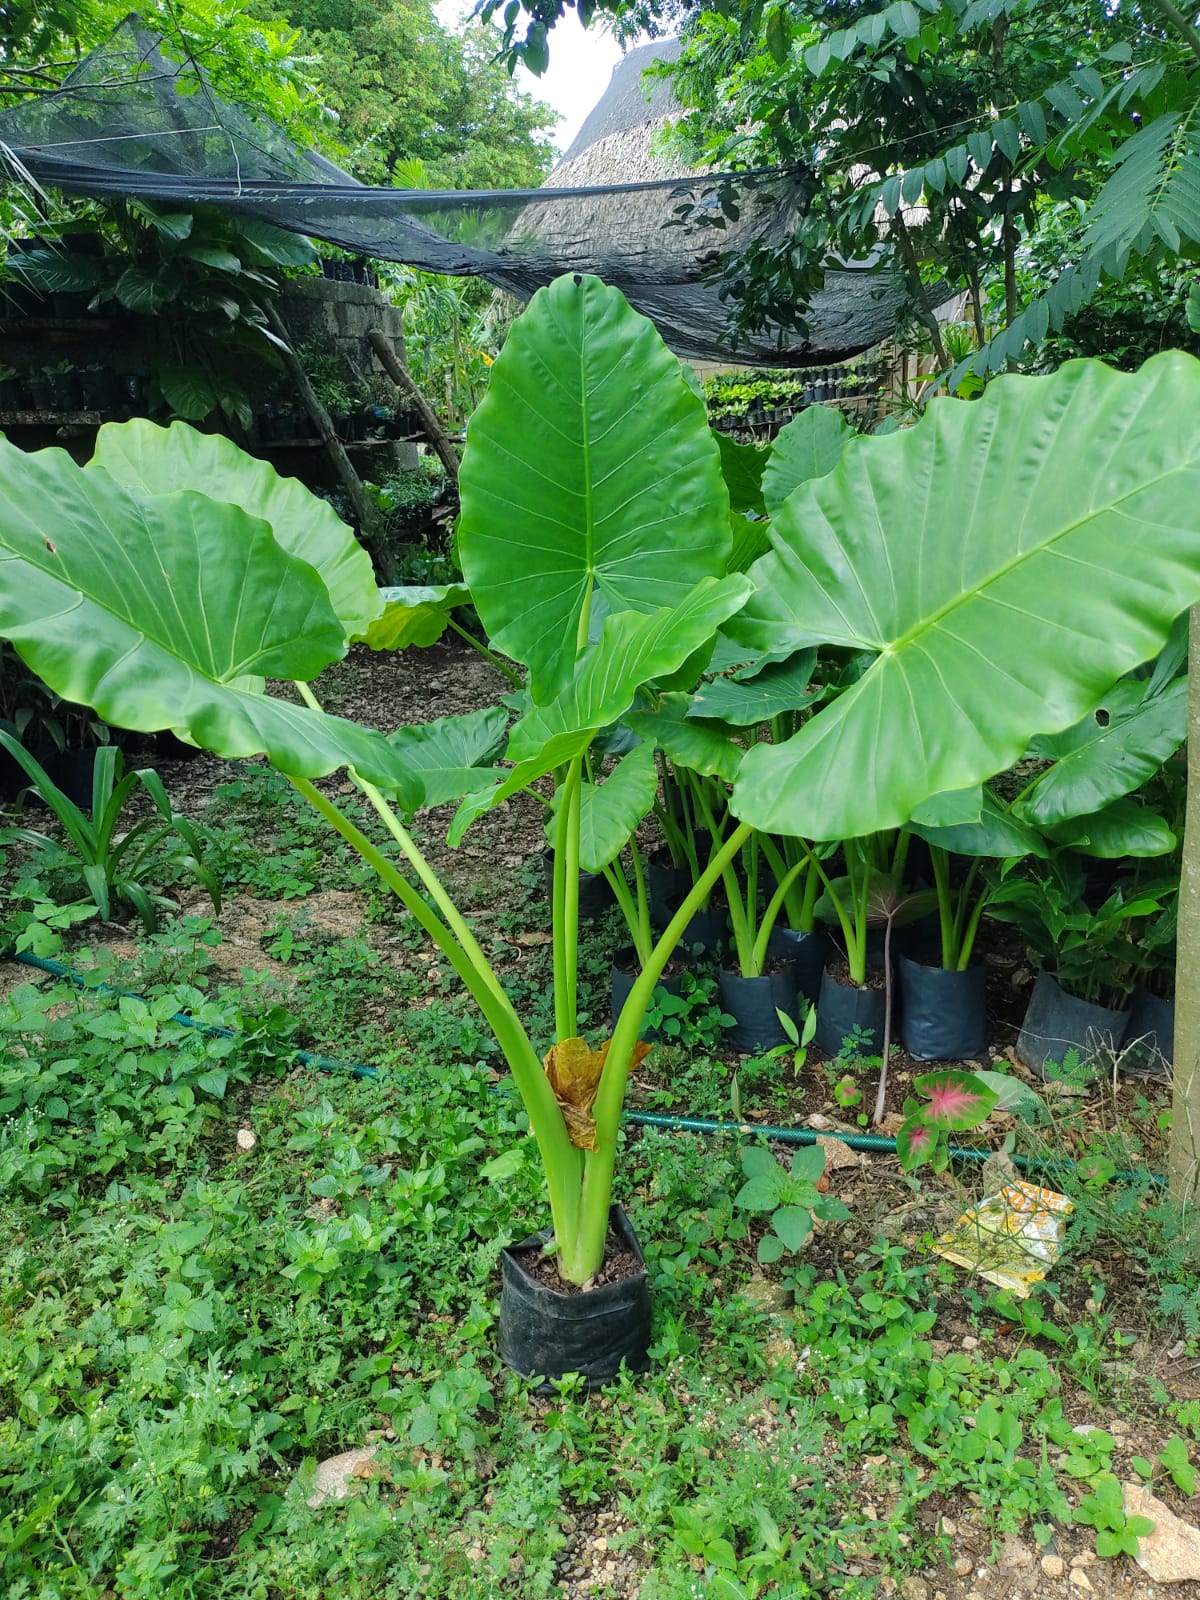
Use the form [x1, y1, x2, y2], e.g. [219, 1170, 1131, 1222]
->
[1013, 678, 1187, 827]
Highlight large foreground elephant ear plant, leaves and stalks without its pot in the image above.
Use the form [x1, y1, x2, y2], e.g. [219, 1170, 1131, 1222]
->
[0, 277, 1200, 1283]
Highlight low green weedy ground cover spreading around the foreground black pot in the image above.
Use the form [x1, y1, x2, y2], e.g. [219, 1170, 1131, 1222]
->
[0, 652, 1200, 1600]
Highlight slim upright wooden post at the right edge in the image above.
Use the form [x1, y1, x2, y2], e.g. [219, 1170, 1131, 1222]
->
[1170, 605, 1200, 1205]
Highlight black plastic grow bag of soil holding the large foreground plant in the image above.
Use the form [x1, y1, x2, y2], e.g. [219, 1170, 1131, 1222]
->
[499, 1205, 650, 1394]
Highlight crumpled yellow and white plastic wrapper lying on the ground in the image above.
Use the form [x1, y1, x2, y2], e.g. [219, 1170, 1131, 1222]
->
[934, 1181, 1075, 1299]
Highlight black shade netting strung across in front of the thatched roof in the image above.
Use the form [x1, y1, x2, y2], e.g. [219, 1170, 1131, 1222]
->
[0, 18, 901, 365]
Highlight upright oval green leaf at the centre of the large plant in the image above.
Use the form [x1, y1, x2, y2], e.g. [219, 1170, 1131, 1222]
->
[458, 274, 730, 701]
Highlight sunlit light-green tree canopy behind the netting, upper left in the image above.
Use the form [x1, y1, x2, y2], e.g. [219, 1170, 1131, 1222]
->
[0, 0, 555, 189]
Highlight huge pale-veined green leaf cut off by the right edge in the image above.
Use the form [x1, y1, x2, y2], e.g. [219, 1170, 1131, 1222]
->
[726, 352, 1200, 838]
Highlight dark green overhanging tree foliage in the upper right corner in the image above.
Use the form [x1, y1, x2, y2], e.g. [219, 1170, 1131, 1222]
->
[478, 0, 1200, 376]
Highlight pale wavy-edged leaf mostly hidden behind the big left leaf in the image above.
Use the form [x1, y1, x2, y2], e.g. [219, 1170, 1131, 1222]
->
[86, 418, 384, 638]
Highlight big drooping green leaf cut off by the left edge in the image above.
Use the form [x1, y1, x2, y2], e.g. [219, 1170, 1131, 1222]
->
[0, 442, 419, 803]
